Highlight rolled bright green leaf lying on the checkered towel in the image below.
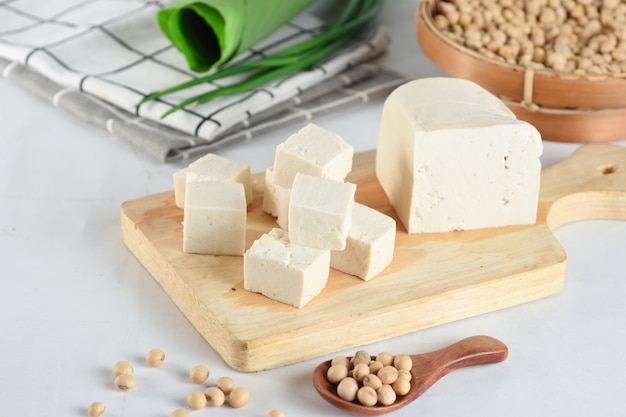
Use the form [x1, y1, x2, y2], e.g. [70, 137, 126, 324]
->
[157, 0, 315, 72]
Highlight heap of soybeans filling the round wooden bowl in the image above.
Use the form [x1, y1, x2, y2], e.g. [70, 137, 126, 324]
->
[433, 0, 626, 76]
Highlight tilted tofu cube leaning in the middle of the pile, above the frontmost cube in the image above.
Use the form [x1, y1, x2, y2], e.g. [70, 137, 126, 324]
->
[289, 173, 356, 250]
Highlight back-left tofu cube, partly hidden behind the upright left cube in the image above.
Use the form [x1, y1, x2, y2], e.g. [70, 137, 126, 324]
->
[174, 153, 252, 208]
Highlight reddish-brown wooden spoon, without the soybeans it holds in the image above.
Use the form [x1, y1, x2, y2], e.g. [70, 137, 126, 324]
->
[313, 336, 508, 416]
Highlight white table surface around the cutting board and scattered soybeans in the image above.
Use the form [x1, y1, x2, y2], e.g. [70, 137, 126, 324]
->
[0, 0, 626, 417]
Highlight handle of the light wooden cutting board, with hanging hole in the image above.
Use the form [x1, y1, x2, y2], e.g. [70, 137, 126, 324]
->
[537, 144, 626, 230]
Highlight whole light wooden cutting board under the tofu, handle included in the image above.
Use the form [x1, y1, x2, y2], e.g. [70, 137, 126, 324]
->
[121, 144, 626, 372]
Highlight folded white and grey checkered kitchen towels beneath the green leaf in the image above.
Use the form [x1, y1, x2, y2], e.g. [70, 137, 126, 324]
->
[0, 0, 406, 161]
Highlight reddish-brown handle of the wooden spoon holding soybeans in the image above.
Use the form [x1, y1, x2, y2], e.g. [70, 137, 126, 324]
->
[412, 336, 508, 396]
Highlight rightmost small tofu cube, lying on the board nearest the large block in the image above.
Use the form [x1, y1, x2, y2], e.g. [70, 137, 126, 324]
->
[330, 203, 396, 281]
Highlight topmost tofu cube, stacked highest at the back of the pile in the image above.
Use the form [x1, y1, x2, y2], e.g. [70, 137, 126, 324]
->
[274, 123, 354, 188]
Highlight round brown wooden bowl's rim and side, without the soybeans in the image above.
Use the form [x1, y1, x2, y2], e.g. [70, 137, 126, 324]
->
[416, 0, 626, 143]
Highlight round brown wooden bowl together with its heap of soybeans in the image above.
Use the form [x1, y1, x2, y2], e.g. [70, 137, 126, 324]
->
[416, 0, 626, 143]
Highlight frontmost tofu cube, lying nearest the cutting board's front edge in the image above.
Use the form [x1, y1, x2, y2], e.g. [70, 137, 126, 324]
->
[243, 228, 330, 308]
